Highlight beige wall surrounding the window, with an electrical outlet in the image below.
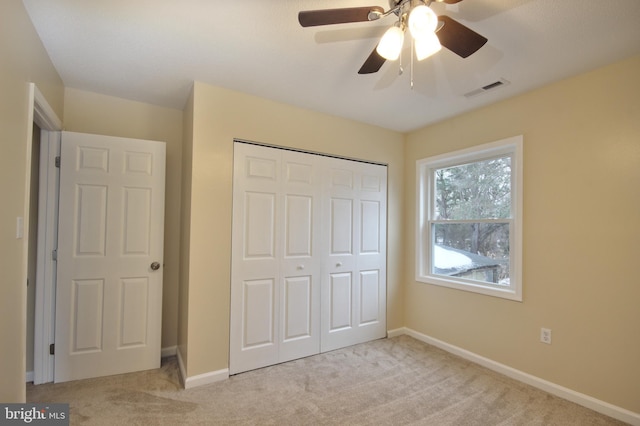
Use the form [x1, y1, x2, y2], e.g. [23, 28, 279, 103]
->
[404, 57, 640, 413]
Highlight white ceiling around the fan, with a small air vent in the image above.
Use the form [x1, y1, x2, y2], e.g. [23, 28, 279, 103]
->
[23, 0, 640, 131]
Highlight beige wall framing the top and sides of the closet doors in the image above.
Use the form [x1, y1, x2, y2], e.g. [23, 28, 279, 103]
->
[180, 82, 404, 377]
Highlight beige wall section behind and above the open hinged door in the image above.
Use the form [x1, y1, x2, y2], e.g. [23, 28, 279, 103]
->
[64, 88, 182, 348]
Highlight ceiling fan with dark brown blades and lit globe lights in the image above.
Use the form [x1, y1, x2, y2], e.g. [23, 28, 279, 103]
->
[298, 0, 487, 74]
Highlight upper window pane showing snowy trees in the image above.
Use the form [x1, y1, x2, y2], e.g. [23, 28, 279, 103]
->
[433, 157, 511, 220]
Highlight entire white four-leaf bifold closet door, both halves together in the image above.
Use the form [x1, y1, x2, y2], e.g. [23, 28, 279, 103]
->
[229, 142, 387, 374]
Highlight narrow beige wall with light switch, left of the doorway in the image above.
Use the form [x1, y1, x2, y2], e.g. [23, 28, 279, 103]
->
[0, 0, 64, 402]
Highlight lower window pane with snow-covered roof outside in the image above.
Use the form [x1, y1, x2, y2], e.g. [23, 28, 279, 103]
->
[431, 222, 509, 286]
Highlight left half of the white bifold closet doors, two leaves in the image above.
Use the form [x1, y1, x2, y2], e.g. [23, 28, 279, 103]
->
[229, 143, 321, 374]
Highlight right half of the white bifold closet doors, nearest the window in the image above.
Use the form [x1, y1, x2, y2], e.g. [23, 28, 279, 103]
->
[321, 158, 387, 352]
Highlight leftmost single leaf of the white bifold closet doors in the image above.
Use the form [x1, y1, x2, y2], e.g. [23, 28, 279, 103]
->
[229, 144, 281, 374]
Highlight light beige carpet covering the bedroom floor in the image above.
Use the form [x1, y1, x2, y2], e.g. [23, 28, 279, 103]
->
[27, 336, 623, 426]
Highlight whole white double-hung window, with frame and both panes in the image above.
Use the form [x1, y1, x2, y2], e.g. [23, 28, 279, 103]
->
[416, 136, 522, 301]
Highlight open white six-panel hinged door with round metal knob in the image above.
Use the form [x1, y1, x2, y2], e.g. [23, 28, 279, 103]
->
[54, 132, 165, 382]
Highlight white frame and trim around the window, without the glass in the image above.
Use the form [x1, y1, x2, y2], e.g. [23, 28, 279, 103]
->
[415, 135, 523, 302]
